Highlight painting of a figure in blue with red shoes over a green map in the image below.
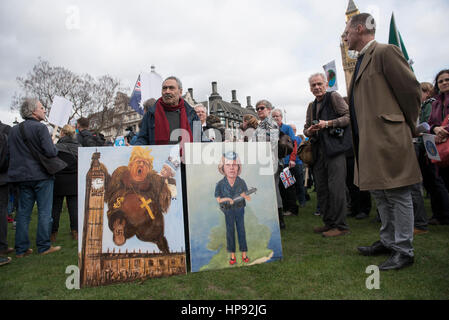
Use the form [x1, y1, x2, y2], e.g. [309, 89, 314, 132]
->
[186, 143, 282, 272]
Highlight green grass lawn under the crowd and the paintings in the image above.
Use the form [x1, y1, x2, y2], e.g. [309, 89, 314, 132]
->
[0, 193, 449, 300]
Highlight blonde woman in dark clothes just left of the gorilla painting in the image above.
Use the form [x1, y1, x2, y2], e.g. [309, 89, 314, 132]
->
[50, 124, 81, 242]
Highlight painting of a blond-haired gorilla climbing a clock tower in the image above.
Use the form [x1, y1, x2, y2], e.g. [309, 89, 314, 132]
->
[78, 145, 186, 286]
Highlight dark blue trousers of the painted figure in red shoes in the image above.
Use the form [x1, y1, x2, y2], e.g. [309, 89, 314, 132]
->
[225, 208, 248, 252]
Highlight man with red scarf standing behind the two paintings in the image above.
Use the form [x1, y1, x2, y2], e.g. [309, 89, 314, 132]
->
[135, 76, 201, 145]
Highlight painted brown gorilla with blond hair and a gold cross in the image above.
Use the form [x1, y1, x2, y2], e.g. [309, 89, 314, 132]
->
[105, 147, 171, 253]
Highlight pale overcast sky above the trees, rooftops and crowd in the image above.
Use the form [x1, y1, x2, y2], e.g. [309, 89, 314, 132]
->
[0, 0, 449, 131]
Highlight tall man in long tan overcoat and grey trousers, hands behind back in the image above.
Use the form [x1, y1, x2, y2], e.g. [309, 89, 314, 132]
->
[344, 13, 421, 270]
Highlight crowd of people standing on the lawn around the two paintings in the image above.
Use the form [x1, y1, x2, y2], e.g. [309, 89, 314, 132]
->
[0, 14, 449, 270]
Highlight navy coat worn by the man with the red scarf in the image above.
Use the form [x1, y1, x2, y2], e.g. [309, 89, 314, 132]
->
[135, 101, 202, 145]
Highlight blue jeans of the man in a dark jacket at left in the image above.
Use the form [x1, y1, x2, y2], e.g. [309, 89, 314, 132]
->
[15, 179, 54, 254]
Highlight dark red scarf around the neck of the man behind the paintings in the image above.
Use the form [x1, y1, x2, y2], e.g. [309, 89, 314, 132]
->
[154, 98, 193, 145]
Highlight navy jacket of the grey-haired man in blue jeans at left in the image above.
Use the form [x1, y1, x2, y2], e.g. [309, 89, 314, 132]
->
[8, 119, 58, 182]
